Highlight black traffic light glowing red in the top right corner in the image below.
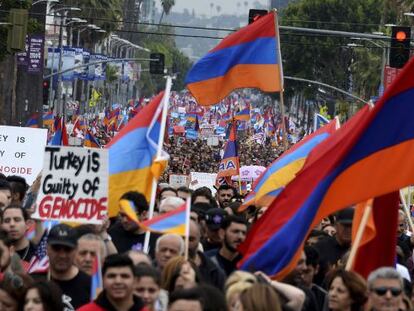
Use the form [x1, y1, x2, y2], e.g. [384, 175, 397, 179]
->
[389, 26, 411, 68]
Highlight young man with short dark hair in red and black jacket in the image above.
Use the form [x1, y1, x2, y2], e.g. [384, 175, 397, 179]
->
[78, 254, 148, 311]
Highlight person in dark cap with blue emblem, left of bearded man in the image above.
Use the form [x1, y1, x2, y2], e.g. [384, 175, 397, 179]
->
[201, 208, 228, 251]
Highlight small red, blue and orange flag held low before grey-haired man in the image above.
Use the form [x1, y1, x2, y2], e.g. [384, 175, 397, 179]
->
[141, 203, 189, 236]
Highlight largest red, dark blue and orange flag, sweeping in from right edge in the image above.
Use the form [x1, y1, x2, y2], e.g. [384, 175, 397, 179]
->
[239, 56, 414, 278]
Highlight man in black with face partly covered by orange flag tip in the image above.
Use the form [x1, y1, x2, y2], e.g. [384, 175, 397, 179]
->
[108, 191, 159, 257]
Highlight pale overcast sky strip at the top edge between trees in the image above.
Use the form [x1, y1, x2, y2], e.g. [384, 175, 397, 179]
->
[156, 0, 269, 16]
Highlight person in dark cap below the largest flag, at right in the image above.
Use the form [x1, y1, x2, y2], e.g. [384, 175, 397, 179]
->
[315, 207, 354, 268]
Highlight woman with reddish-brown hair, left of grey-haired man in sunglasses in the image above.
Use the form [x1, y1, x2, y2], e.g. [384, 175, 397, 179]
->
[328, 270, 368, 311]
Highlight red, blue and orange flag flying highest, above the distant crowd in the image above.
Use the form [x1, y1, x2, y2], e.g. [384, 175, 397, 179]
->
[186, 12, 282, 105]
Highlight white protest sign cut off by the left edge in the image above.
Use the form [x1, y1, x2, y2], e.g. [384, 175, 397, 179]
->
[0, 126, 47, 185]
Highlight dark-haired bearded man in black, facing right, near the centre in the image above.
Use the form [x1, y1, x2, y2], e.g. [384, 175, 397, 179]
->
[206, 215, 247, 276]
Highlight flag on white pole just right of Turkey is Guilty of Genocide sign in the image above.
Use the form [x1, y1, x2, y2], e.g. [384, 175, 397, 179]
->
[107, 92, 168, 217]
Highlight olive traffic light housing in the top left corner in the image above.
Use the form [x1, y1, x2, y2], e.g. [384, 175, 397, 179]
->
[7, 9, 28, 53]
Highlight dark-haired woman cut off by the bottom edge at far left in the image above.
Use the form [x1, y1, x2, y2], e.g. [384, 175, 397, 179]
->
[23, 281, 64, 311]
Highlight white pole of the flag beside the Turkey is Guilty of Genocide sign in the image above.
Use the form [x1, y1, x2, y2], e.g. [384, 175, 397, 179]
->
[144, 76, 172, 254]
